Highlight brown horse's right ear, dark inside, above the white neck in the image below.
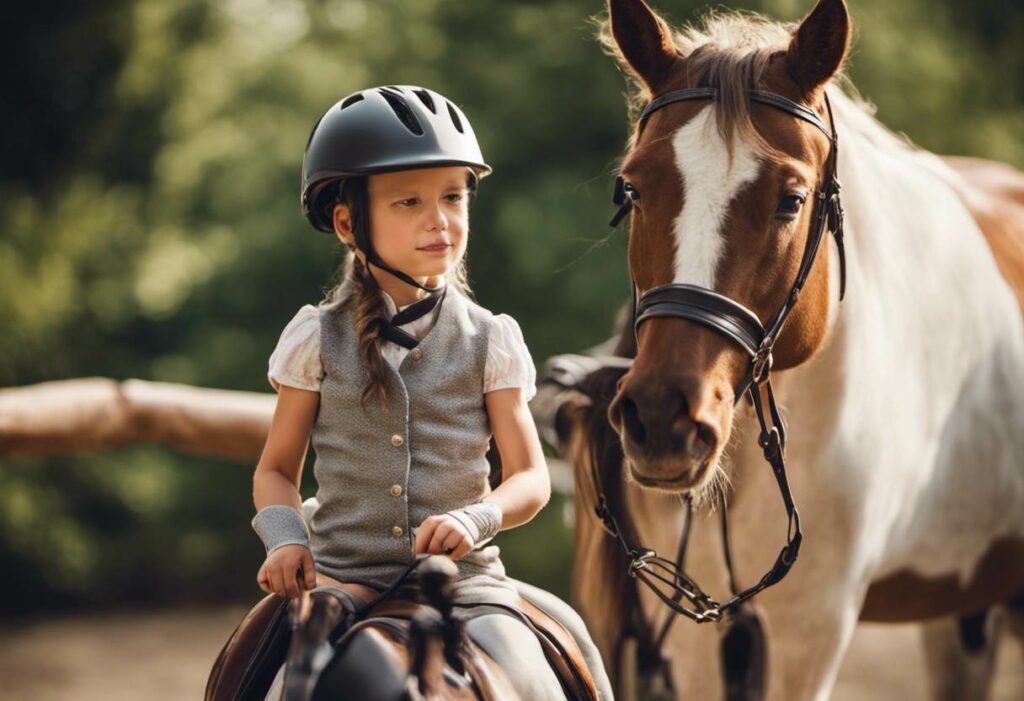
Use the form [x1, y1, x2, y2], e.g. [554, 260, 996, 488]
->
[785, 0, 850, 95]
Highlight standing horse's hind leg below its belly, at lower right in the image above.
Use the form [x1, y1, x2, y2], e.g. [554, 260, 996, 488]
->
[921, 609, 1004, 701]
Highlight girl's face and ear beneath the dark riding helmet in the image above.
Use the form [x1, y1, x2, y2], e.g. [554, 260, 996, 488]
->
[335, 166, 469, 279]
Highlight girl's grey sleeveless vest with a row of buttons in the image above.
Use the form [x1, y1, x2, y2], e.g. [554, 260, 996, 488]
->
[310, 290, 504, 588]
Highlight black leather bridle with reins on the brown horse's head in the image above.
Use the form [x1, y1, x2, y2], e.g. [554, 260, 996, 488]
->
[595, 88, 846, 622]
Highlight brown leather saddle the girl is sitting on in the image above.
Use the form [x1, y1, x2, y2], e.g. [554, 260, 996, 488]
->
[205, 564, 597, 701]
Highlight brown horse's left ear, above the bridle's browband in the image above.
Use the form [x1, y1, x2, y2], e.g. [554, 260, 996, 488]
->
[608, 0, 679, 92]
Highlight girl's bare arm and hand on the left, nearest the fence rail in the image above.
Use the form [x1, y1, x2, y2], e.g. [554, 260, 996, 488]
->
[253, 385, 319, 599]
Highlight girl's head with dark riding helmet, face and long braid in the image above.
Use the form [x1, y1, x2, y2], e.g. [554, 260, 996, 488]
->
[302, 86, 490, 400]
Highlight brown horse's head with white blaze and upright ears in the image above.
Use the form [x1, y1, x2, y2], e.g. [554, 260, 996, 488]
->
[608, 0, 850, 491]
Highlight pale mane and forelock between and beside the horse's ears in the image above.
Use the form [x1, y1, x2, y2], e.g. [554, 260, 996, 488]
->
[595, 10, 913, 155]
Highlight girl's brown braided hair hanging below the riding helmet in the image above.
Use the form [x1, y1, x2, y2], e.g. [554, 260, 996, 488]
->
[321, 171, 476, 407]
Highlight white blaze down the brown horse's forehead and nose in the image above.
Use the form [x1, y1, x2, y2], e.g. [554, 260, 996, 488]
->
[672, 105, 760, 289]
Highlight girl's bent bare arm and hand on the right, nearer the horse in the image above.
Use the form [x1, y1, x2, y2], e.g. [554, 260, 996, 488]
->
[416, 388, 551, 560]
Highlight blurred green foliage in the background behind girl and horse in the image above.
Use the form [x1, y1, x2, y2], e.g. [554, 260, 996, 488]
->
[0, 0, 1024, 612]
